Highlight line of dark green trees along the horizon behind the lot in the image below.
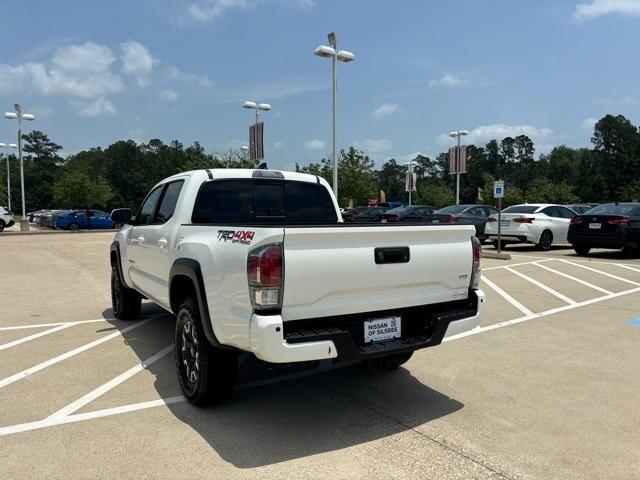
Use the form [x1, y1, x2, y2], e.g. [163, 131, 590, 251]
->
[0, 115, 640, 212]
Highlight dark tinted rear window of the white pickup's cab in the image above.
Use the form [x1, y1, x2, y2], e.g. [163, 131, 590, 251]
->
[191, 179, 338, 224]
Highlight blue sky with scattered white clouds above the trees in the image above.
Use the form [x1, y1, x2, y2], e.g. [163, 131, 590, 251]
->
[0, 0, 640, 168]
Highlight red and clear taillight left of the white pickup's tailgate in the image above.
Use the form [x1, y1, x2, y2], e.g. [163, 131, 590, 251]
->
[247, 243, 284, 310]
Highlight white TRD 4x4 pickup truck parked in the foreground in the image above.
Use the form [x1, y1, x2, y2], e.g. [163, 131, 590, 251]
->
[111, 169, 486, 405]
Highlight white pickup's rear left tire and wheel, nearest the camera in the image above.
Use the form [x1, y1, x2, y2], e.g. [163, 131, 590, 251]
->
[174, 298, 238, 406]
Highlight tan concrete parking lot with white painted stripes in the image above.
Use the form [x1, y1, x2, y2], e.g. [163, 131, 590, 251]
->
[0, 233, 640, 479]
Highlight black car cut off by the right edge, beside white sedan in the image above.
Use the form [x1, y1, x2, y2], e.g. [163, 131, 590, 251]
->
[567, 202, 640, 255]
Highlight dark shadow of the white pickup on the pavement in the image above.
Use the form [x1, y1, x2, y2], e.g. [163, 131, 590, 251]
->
[104, 304, 464, 468]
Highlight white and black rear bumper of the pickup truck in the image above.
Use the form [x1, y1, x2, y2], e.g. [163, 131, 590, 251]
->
[251, 290, 486, 363]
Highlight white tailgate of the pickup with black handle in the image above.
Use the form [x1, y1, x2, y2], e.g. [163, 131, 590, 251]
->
[282, 225, 475, 321]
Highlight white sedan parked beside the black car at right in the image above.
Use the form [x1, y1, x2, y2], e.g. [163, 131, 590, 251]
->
[484, 203, 577, 250]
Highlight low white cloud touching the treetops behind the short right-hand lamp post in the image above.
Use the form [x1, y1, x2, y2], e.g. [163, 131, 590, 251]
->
[436, 124, 554, 151]
